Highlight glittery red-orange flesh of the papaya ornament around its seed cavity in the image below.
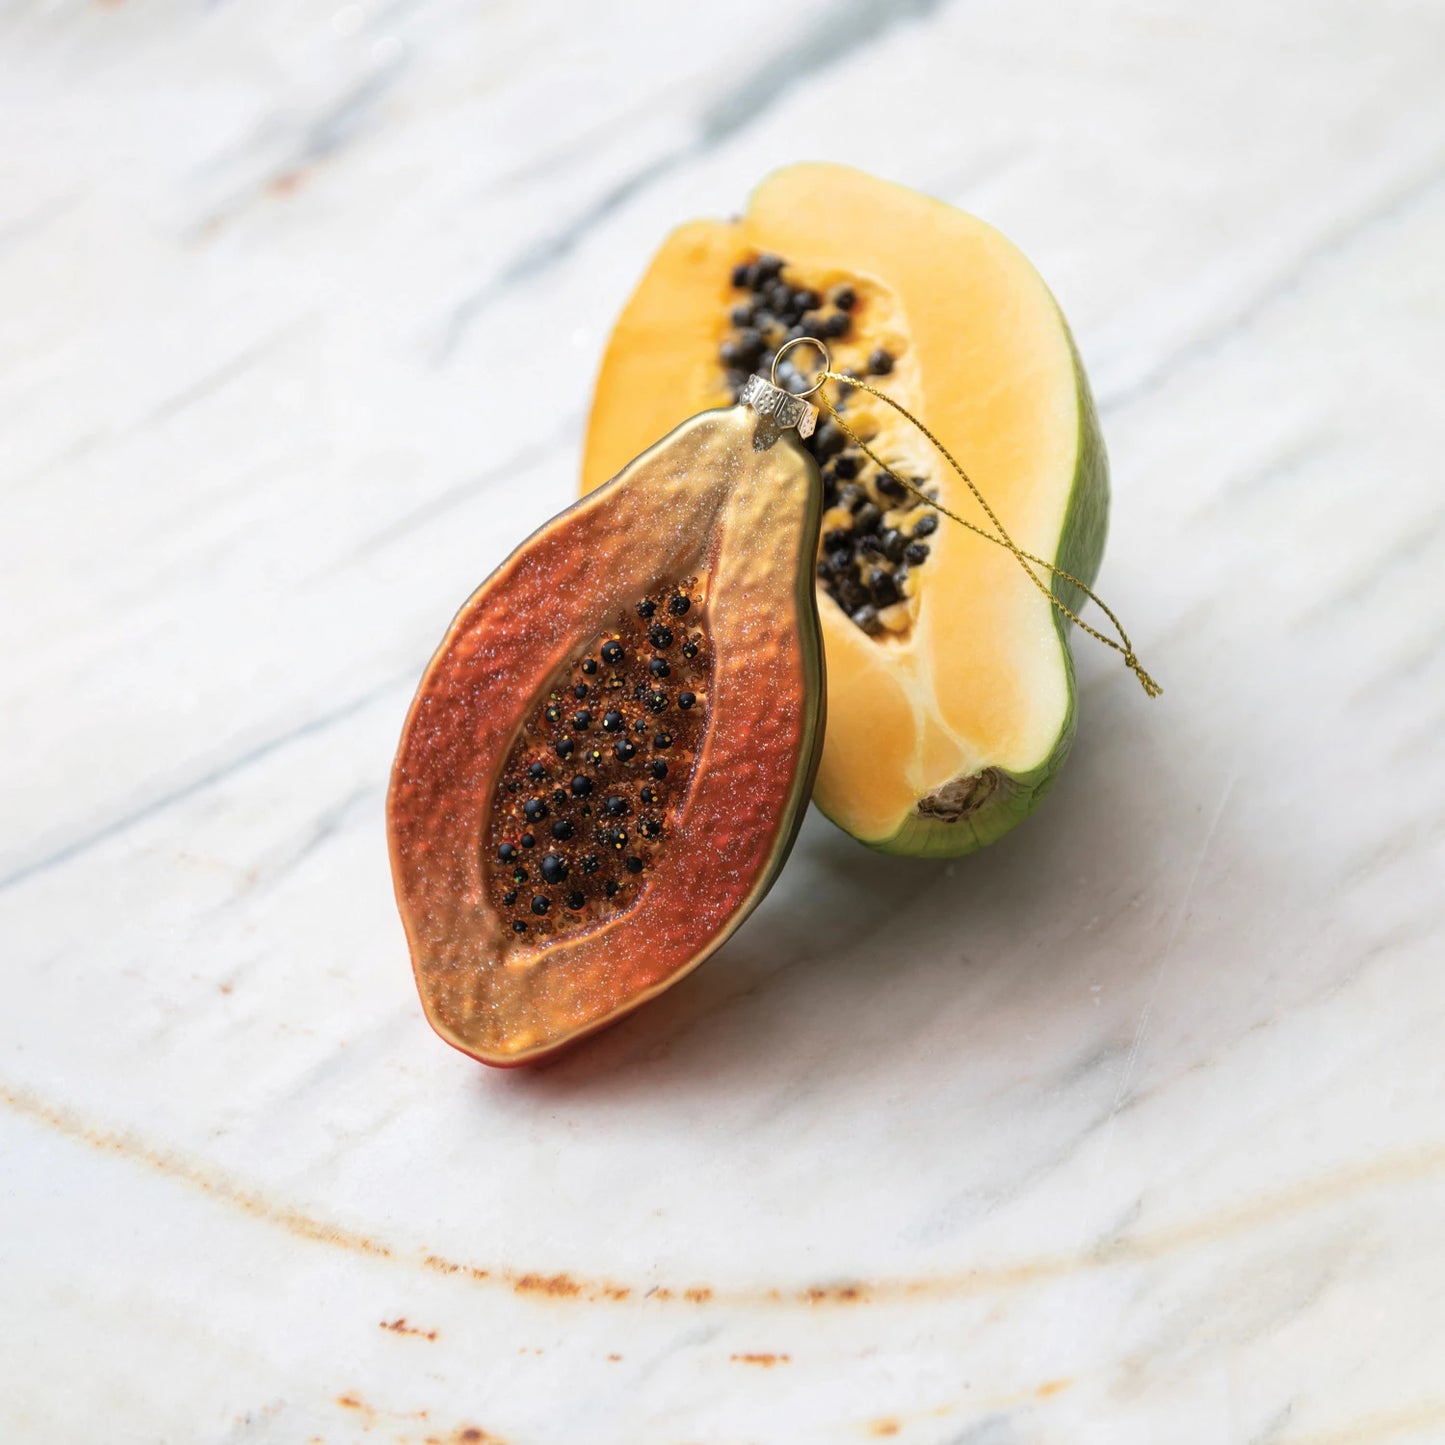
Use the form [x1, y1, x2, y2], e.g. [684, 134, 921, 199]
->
[387, 407, 822, 1065]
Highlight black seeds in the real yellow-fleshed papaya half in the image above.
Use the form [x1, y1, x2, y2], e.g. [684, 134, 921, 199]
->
[718, 254, 938, 633]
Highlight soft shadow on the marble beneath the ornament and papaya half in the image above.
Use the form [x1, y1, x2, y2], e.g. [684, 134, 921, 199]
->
[477, 676, 1231, 1107]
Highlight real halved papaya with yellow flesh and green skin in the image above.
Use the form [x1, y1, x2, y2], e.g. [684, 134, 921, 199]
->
[582, 163, 1108, 855]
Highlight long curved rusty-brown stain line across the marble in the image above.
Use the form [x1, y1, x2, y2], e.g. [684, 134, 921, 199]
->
[0, 1084, 1445, 1317]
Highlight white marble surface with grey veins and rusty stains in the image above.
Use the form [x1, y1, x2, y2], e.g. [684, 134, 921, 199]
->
[0, 0, 1445, 1445]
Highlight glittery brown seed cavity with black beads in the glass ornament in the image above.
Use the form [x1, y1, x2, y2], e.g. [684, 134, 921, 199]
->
[483, 578, 711, 941]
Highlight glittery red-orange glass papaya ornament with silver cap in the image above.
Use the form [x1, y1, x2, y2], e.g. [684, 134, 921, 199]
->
[387, 377, 824, 1066]
